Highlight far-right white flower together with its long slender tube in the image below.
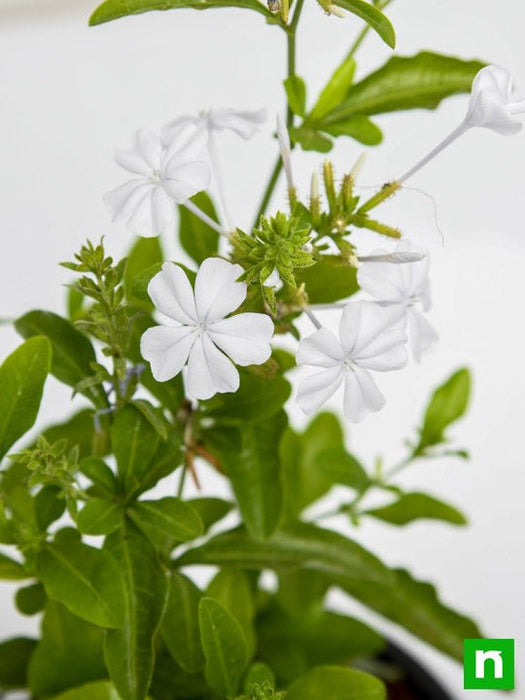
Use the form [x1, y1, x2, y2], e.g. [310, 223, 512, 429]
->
[397, 66, 525, 184]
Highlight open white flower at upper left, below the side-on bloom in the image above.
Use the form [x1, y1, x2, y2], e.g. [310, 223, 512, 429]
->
[104, 130, 210, 237]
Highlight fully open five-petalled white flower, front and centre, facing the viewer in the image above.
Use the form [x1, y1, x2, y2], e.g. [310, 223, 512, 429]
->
[140, 258, 273, 399]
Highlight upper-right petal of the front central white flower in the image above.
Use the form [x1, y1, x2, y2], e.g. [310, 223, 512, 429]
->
[195, 258, 246, 323]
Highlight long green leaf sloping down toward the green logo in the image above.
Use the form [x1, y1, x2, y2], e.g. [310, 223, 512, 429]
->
[340, 569, 483, 661]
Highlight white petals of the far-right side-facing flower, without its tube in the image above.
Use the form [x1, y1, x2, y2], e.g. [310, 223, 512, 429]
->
[465, 66, 525, 135]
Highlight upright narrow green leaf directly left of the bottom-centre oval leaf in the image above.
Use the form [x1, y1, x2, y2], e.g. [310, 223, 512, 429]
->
[161, 571, 204, 673]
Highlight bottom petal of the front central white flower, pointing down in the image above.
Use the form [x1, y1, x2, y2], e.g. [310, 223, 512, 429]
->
[186, 333, 240, 400]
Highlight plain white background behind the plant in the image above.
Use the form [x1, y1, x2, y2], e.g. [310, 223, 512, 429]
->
[0, 0, 525, 700]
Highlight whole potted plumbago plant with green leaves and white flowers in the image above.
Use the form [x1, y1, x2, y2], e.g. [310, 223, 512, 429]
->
[0, 0, 524, 700]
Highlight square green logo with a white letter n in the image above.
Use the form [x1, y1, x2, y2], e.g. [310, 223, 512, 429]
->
[463, 639, 514, 690]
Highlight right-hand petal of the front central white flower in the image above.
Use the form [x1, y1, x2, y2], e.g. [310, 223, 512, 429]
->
[208, 313, 273, 367]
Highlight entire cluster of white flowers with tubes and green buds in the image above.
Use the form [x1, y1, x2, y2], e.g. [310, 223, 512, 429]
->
[106, 66, 525, 422]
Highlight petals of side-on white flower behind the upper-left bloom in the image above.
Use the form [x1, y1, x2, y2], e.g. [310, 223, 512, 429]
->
[162, 109, 266, 144]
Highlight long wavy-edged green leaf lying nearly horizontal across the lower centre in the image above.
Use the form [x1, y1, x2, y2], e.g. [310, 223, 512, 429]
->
[177, 522, 392, 585]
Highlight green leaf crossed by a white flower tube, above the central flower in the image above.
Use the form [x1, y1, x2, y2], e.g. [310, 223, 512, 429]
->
[179, 192, 219, 265]
